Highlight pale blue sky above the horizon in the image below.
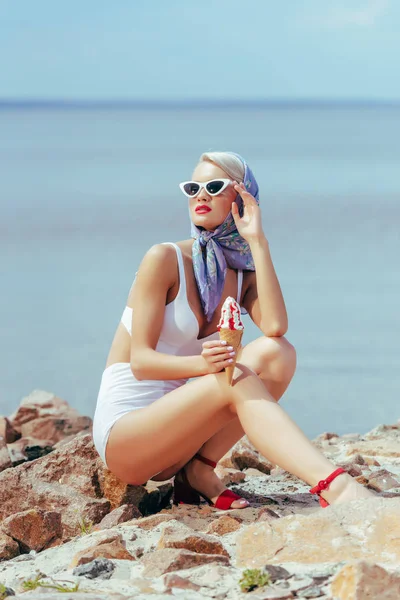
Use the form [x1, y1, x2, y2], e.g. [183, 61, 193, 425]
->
[0, 0, 400, 101]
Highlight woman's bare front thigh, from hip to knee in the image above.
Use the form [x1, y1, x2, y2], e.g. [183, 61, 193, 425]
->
[106, 372, 241, 484]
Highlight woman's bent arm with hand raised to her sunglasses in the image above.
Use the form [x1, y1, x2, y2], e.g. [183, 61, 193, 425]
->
[232, 184, 288, 337]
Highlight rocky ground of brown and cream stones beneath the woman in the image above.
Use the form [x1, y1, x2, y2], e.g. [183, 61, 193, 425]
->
[0, 391, 400, 600]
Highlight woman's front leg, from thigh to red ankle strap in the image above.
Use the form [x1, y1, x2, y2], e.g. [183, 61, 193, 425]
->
[106, 364, 372, 502]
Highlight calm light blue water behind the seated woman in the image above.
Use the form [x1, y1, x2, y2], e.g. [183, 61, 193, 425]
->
[0, 108, 400, 436]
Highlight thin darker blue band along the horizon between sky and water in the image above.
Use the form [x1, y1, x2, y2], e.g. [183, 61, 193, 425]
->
[0, 98, 400, 109]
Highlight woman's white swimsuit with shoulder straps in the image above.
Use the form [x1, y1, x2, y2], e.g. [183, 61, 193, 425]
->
[93, 242, 243, 466]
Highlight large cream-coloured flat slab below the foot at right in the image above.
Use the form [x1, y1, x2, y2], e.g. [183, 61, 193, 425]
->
[237, 498, 400, 567]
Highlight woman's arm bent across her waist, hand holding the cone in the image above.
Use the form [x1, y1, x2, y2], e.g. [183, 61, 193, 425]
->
[129, 244, 231, 380]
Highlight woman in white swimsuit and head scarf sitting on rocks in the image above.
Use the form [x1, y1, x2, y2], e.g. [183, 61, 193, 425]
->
[93, 152, 371, 509]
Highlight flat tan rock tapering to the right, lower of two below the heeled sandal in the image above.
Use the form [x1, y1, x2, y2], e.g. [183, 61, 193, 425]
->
[141, 548, 229, 577]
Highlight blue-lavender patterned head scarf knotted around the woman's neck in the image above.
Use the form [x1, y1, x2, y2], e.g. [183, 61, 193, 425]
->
[191, 152, 259, 322]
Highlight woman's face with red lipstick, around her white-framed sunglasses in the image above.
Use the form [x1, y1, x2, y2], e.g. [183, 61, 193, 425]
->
[188, 161, 237, 231]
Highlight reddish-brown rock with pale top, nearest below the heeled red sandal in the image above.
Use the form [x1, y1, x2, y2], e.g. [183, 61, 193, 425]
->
[157, 522, 229, 556]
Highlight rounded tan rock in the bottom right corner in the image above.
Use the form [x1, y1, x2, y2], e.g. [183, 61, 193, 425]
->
[331, 561, 400, 600]
